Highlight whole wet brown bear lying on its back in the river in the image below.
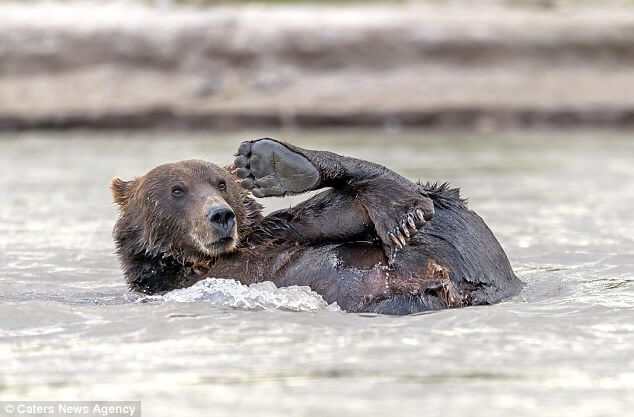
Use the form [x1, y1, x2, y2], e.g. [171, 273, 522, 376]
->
[111, 138, 522, 314]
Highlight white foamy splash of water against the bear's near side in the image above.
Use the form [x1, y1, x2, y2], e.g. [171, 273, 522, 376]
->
[159, 278, 341, 311]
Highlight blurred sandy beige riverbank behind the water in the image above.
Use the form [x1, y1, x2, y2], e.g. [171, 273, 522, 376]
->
[0, 3, 634, 130]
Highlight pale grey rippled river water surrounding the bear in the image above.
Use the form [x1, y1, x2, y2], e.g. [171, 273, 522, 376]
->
[0, 130, 634, 417]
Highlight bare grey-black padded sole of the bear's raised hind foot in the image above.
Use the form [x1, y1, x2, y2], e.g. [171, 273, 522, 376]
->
[234, 138, 320, 197]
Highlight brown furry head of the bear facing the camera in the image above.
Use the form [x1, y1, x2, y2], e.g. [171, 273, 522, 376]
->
[111, 160, 262, 265]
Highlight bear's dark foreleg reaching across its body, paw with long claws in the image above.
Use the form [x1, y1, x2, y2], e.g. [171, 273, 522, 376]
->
[254, 178, 434, 264]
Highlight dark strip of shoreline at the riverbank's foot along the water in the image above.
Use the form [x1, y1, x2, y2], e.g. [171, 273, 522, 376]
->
[0, 107, 634, 132]
